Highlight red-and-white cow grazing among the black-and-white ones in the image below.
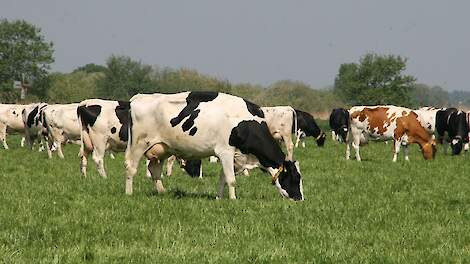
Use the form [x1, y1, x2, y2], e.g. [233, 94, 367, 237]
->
[346, 105, 436, 162]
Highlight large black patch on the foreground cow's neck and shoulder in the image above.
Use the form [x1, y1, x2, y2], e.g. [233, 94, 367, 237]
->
[229, 120, 285, 168]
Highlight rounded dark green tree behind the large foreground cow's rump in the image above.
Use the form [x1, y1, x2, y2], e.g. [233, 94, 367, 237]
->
[97, 55, 157, 100]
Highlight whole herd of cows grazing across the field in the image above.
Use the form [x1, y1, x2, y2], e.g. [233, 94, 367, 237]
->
[0, 91, 469, 201]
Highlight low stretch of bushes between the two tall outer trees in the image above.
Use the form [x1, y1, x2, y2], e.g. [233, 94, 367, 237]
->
[14, 56, 344, 112]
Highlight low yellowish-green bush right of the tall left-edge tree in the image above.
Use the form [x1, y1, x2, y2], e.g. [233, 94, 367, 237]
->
[47, 71, 104, 103]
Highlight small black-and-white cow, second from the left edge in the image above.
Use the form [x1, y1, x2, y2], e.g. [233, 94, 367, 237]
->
[21, 103, 48, 151]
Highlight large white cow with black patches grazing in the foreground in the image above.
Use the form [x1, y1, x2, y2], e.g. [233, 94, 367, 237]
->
[125, 92, 303, 200]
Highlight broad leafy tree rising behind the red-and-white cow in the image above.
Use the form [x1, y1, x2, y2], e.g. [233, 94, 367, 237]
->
[334, 53, 416, 106]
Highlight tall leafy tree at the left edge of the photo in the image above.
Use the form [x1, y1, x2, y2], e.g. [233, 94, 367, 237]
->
[0, 19, 54, 100]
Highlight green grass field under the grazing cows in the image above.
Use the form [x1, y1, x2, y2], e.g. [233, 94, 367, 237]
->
[0, 127, 470, 263]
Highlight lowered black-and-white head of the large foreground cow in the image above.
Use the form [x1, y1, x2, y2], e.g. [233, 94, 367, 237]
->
[273, 161, 304, 201]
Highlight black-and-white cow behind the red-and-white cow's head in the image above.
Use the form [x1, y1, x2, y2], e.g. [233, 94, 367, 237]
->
[415, 107, 469, 155]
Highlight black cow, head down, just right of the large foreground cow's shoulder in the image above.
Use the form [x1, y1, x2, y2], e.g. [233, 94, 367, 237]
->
[291, 109, 326, 148]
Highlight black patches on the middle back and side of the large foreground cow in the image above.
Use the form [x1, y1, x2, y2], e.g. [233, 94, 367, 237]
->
[170, 92, 219, 133]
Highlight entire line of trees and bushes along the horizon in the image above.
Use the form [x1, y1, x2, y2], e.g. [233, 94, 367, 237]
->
[0, 19, 470, 116]
